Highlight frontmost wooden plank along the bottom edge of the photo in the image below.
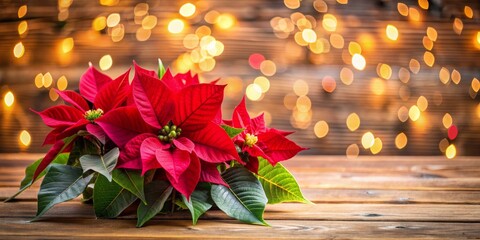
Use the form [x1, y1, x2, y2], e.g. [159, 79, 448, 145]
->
[0, 218, 480, 239]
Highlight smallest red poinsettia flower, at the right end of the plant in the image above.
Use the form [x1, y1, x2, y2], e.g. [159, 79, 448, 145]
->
[224, 97, 306, 173]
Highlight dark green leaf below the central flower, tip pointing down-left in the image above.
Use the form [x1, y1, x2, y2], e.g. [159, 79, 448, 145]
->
[137, 180, 173, 227]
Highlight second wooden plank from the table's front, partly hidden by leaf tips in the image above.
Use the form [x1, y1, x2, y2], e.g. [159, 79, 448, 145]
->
[0, 202, 480, 223]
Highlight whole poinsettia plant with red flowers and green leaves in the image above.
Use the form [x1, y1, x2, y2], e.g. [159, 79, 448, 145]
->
[7, 61, 309, 227]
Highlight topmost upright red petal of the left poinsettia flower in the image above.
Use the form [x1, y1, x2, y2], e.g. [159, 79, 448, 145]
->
[80, 66, 112, 103]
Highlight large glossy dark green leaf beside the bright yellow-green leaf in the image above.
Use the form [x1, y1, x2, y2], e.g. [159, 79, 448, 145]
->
[211, 167, 268, 225]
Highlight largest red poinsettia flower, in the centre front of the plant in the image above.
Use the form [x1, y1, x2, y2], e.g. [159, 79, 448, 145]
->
[97, 62, 240, 198]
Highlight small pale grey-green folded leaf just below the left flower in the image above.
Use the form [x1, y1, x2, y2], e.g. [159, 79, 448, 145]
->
[80, 148, 120, 182]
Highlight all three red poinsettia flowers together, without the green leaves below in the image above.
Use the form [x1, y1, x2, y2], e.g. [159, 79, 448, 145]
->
[33, 63, 304, 198]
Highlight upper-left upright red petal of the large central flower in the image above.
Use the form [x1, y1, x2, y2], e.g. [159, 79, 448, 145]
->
[132, 70, 173, 128]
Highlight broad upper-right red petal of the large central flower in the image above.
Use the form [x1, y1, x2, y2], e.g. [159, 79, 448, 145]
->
[173, 84, 225, 131]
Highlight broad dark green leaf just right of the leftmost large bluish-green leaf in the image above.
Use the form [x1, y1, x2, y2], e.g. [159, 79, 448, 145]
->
[93, 175, 137, 218]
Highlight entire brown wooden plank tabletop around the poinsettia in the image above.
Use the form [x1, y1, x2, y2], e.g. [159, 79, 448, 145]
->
[0, 154, 480, 239]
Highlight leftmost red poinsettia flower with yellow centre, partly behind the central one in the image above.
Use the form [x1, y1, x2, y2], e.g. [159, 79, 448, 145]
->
[33, 67, 130, 182]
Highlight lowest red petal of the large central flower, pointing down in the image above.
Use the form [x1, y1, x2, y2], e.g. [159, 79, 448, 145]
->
[167, 154, 201, 199]
